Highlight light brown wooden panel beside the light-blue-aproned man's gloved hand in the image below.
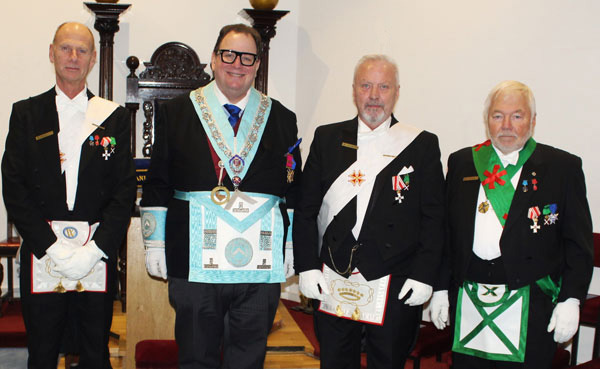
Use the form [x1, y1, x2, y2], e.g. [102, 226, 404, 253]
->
[125, 217, 175, 368]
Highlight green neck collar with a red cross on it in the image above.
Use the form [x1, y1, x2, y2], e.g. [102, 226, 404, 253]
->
[472, 138, 536, 227]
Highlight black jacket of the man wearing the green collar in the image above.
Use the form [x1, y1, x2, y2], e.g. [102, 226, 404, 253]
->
[436, 143, 593, 302]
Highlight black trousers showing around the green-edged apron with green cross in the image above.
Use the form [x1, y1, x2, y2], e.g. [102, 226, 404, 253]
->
[452, 262, 556, 369]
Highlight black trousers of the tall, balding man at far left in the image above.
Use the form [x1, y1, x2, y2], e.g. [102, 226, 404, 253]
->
[21, 268, 114, 369]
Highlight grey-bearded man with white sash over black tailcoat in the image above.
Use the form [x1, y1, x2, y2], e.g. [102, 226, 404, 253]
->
[293, 55, 444, 368]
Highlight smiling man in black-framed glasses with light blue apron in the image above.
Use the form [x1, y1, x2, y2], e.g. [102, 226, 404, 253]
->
[141, 24, 301, 368]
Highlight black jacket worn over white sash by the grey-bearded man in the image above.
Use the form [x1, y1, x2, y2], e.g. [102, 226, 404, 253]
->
[293, 117, 444, 285]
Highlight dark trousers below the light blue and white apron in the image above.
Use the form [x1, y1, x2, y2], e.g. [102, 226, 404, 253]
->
[169, 278, 280, 369]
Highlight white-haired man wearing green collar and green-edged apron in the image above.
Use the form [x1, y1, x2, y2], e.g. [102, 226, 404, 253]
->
[431, 81, 593, 369]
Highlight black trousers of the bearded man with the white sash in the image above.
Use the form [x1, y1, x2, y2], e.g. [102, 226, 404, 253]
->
[315, 277, 422, 369]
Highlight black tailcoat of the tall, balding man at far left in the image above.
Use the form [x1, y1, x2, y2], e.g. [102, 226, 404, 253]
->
[2, 87, 136, 274]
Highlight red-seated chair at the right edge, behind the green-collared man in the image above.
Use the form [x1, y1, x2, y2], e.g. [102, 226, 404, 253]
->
[571, 233, 600, 365]
